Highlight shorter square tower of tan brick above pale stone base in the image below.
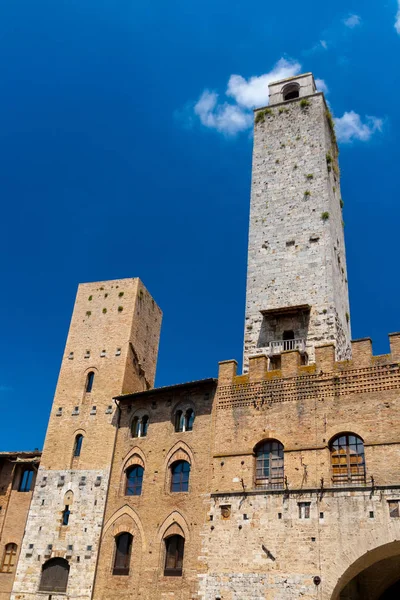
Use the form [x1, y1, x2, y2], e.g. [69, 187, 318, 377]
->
[11, 279, 162, 600]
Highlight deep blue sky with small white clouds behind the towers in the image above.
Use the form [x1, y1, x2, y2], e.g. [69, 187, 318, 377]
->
[0, 0, 400, 450]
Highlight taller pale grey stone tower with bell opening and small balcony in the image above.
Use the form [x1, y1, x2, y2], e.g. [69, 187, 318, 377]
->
[244, 73, 351, 371]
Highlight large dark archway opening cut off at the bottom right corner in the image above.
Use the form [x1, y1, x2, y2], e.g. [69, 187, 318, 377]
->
[332, 541, 400, 600]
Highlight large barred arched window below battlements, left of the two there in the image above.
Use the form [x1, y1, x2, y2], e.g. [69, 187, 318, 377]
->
[255, 440, 283, 489]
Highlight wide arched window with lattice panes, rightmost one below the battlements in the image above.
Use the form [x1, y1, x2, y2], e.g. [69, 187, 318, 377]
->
[329, 433, 365, 485]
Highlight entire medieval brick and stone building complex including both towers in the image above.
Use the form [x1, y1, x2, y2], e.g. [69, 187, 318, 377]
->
[0, 74, 400, 600]
